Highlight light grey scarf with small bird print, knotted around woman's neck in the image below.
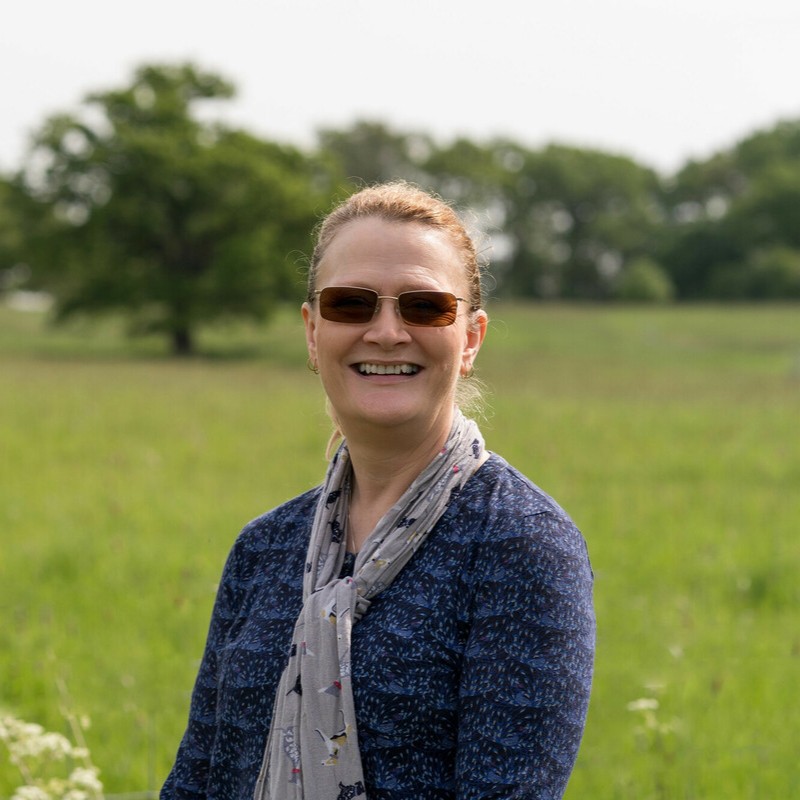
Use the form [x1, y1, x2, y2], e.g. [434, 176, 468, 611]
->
[255, 409, 483, 800]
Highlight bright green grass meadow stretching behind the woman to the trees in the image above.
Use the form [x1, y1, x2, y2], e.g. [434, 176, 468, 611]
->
[0, 304, 800, 800]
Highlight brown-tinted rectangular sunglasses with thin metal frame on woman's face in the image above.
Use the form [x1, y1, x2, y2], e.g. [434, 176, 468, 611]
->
[314, 286, 467, 328]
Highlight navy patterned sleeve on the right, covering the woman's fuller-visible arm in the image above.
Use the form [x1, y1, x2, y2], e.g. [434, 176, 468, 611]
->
[456, 511, 595, 800]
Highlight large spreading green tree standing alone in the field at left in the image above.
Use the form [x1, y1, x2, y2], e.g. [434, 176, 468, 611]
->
[24, 64, 327, 354]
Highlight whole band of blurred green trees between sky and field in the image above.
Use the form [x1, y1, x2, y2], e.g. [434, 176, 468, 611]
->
[0, 64, 800, 353]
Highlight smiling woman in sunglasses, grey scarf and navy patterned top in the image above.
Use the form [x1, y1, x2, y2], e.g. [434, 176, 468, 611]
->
[161, 183, 594, 800]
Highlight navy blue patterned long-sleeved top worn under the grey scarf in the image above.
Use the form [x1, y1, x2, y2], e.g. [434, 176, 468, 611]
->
[161, 454, 595, 800]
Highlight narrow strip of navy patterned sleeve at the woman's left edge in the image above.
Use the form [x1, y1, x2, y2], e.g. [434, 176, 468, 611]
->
[160, 542, 247, 800]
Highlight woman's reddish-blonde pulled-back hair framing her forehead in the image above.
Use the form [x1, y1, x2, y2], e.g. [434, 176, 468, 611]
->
[308, 181, 483, 311]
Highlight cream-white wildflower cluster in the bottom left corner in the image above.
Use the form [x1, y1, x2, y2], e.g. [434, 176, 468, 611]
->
[0, 714, 103, 800]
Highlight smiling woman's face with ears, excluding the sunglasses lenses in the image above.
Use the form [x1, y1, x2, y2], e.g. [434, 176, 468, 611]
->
[303, 217, 487, 437]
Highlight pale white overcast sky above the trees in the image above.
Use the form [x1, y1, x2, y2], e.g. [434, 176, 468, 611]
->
[0, 0, 800, 174]
